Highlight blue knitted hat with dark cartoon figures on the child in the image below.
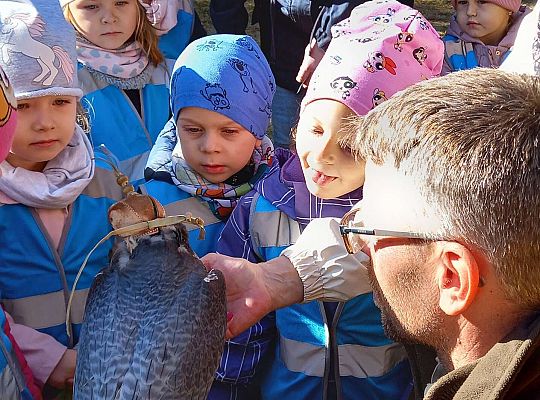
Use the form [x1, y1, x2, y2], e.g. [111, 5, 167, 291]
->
[171, 35, 276, 139]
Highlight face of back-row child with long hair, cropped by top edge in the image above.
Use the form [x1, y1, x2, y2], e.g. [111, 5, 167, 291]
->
[68, 0, 139, 50]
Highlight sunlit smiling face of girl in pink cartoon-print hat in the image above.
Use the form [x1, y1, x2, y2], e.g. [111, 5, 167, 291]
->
[296, 99, 365, 199]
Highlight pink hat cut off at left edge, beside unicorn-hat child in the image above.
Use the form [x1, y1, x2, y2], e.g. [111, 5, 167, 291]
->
[0, 68, 17, 162]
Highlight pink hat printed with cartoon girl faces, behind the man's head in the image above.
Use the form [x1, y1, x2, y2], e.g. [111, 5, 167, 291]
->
[302, 0, 444, 115]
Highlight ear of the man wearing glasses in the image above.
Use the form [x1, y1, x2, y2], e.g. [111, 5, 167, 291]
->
[436, 242, 480, 315]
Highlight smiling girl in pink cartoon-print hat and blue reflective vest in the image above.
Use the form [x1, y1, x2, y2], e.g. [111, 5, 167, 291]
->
[218, 1, 443, 400]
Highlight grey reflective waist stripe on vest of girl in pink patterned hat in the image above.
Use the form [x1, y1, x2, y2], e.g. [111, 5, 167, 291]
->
[280, 336, 407, 378]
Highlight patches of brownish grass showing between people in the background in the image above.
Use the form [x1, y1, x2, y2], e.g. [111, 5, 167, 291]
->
[195, 0, 536, 40]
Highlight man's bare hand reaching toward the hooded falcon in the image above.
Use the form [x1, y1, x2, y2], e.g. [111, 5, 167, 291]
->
[201, 253, 303, 339]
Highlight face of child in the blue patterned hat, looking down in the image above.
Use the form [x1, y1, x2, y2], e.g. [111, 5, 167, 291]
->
[176, 107, 261, 183]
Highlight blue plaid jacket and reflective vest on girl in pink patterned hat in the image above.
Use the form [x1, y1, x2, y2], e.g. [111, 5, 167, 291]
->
[218, 151, 412, 400]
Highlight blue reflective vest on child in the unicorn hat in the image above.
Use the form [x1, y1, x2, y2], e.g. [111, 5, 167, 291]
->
[0, 156, 122, 348]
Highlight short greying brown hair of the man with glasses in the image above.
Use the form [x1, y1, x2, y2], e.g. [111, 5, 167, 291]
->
[344, 68, 540, 309]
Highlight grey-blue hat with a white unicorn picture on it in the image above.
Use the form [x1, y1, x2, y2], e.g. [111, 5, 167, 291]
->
[0, 0, 83, 100]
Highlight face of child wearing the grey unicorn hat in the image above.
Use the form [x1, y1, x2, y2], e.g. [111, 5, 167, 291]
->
[6, 96, 77, 171]
